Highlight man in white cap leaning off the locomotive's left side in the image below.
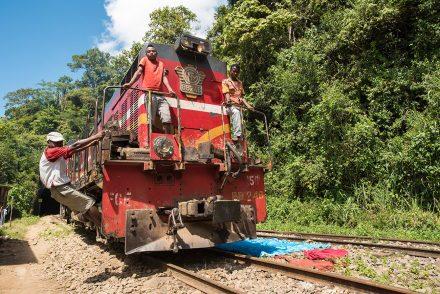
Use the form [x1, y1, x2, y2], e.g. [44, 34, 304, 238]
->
[39, 132, 105, 228]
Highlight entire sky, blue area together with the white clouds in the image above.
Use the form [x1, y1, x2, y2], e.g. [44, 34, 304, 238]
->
[0, 0, 226, 116]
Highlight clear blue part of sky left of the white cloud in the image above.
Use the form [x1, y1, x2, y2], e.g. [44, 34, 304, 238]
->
[0, 0, 106, 115]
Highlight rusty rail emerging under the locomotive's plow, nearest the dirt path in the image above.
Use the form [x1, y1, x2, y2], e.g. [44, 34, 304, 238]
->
[144, 256, 245, 294]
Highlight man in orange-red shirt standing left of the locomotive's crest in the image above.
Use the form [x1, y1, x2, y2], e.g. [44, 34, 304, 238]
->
[123, 44, 176, 134]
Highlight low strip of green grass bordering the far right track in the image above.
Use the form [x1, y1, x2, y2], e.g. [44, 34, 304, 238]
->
[257, 197, 440, 242]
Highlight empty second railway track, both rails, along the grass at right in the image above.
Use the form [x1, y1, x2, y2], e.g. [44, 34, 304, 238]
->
[257, 230, 440, 258]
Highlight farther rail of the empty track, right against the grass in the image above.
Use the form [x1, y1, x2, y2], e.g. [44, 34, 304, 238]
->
[257, 230, 440, 246]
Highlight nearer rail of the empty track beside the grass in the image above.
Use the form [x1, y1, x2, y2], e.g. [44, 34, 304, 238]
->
[257, 231, 440, 258]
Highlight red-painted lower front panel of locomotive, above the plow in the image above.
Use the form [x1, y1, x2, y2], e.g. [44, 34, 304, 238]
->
[102, 164, 266, 237]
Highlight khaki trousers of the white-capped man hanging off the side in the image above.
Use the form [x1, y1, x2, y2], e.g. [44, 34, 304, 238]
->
[50, 184, 95, 213]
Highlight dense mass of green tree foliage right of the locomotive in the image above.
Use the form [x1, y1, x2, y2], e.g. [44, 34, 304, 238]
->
[210, 0, 440, 210]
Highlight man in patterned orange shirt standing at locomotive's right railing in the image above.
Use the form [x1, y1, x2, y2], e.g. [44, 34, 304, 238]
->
[222, 64, 254, 144]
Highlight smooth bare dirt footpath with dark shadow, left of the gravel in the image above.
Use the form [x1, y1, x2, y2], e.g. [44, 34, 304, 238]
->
[0, 217, 62, 294]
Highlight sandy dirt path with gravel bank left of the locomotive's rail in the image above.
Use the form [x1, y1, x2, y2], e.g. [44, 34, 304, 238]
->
[0, 216, 194, 294]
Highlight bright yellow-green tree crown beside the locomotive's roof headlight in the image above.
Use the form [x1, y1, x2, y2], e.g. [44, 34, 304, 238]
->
[208, 0, 294, 84]
